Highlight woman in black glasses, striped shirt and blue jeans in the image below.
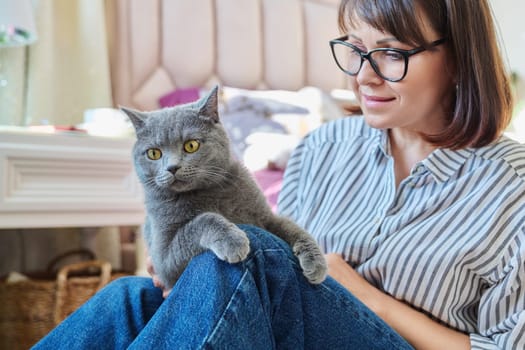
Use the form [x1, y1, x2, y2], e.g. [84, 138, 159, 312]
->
[36, 0, 525, 349]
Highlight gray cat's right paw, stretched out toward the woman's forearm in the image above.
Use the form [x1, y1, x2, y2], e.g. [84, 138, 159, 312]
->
[293, 239, 328, 284]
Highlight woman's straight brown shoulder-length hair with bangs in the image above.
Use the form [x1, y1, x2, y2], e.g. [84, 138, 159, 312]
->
[339, 0, 513, 149]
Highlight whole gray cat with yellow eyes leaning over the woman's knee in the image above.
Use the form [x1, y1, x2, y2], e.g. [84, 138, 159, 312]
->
[122, 87, 327, 289]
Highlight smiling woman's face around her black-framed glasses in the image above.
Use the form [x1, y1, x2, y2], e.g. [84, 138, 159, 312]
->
[348, 13, 455, 134]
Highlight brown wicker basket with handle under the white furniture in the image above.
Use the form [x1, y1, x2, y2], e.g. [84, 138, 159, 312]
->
[0, 260, 113, 349]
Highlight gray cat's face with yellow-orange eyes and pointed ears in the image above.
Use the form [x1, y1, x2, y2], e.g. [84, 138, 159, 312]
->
[123, 89, 230, 193]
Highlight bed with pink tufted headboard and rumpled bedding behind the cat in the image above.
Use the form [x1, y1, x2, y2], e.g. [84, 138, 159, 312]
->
[104, 0, 353, 208]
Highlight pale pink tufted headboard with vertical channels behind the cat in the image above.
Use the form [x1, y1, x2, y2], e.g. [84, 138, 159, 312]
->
[108, 0, 346, 109]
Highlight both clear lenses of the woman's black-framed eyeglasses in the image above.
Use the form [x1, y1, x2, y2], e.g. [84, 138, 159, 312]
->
[333, 43, 406, 80]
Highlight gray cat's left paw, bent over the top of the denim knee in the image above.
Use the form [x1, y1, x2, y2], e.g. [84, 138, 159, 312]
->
[210, 226, 250, 264]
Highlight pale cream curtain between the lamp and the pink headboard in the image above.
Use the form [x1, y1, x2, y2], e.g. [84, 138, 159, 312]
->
[24, 0, 112, 125]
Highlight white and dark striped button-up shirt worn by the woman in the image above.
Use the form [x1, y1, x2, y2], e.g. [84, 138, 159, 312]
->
[279, 117, 525, 349]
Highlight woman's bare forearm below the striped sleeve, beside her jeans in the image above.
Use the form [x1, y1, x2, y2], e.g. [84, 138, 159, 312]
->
[326, 254, 470, 350]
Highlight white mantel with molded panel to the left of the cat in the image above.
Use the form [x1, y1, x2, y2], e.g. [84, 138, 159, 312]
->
[0, 128, 144, 228]
